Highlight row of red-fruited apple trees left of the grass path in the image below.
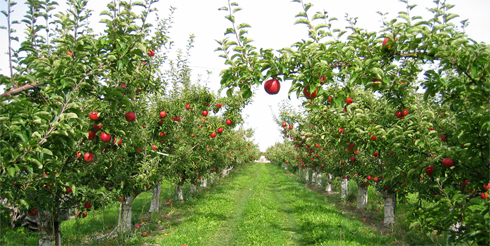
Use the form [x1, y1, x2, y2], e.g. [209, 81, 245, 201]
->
[0, 0, 258, 245]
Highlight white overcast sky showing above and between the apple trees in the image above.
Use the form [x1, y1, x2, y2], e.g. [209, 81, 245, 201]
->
[0, 0, 490, 151]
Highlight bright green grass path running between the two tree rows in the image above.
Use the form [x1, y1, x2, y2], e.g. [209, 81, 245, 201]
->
[151, 163, 391, 246]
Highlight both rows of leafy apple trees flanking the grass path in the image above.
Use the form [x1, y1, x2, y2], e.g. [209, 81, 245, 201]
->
[0, 0, 490, 245]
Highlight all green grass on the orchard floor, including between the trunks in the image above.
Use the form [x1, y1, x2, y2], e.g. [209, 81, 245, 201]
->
[4, 163, 433, 246]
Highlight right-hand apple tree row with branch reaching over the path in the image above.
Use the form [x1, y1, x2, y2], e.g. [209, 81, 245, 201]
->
[218, 0, 490, 244]
